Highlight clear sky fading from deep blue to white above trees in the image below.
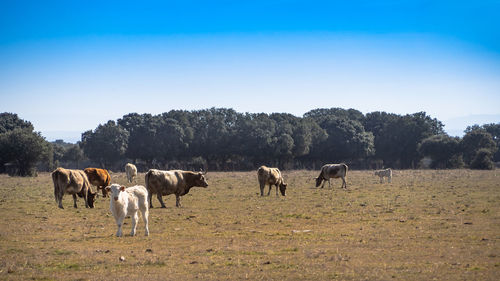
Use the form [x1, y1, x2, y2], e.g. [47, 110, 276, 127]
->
[0, 1, 500, 142]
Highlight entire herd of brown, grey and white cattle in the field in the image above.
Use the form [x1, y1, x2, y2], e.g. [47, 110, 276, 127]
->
[51, 163, 392, 236]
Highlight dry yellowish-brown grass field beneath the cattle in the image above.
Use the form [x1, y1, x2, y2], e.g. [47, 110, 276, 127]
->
[0, 167, 500, 280]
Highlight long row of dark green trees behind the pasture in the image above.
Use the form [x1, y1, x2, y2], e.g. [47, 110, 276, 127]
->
[0, 108, 500, 175]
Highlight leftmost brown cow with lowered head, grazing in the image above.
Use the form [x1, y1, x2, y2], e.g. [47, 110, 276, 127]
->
[51, 168, 97, 209]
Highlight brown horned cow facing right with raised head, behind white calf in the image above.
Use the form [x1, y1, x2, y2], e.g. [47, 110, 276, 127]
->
[145, 169, 208, 208]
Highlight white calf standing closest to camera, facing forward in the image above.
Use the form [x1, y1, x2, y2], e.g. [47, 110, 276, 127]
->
[106, 183, 149, 237]
